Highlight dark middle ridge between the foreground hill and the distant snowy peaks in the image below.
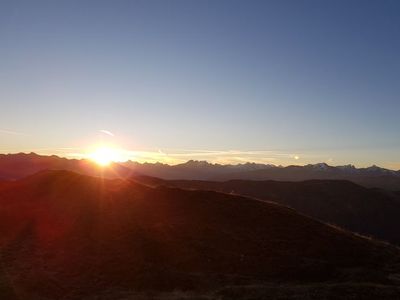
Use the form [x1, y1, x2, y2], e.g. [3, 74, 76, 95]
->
[136, 176, 400, 244]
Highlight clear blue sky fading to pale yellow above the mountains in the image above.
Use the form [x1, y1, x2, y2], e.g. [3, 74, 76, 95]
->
[0, 0, 400, 169]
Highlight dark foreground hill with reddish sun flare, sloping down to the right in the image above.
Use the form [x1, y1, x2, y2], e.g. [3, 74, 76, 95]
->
[0, 171, 400, 299]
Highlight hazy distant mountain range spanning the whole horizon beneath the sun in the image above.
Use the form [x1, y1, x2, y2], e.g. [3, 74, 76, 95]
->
[0, 153, 400, 191]
